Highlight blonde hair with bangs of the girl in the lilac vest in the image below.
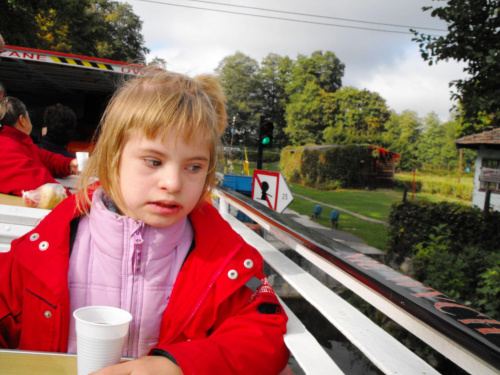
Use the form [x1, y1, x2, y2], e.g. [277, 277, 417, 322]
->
[78, 71, 227, 210]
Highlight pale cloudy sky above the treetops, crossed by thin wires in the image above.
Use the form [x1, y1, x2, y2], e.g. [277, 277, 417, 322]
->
[121, 0, 466, 122]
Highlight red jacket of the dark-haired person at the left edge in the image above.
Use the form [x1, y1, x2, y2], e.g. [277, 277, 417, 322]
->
[0, 126, 72, 196]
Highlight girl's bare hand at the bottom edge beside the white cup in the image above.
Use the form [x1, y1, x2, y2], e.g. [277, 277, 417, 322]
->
[92, 356, 182, 375]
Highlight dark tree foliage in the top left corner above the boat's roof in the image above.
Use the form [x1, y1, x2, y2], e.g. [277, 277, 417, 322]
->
[0, 0, 149, 63]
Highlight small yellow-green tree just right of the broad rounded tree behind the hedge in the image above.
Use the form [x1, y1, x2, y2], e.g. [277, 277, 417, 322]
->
[382, 110, 422, 171]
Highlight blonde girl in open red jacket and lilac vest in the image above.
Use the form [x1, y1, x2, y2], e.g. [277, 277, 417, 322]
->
[0, 72, 288, 375]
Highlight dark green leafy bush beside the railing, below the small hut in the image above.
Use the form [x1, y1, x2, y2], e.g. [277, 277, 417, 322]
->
[386, 202, 500, 318]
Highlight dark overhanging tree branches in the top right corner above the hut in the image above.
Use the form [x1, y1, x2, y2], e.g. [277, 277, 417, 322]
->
[413, 0, 500, 135]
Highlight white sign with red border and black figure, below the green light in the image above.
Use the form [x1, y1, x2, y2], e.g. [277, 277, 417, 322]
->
[252, 169, 293, 213]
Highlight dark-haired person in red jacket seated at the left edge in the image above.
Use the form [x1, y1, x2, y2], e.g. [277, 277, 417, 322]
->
[0, 96, 78, 196]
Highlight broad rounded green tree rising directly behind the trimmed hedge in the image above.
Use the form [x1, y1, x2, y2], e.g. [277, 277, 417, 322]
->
[324, 87, 390, 143]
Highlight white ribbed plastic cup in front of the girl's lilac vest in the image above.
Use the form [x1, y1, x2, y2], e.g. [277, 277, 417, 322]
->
[73, 306, 132, 375]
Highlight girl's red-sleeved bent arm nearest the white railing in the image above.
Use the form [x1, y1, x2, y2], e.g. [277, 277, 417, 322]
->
[156, 273, 289, 375]
